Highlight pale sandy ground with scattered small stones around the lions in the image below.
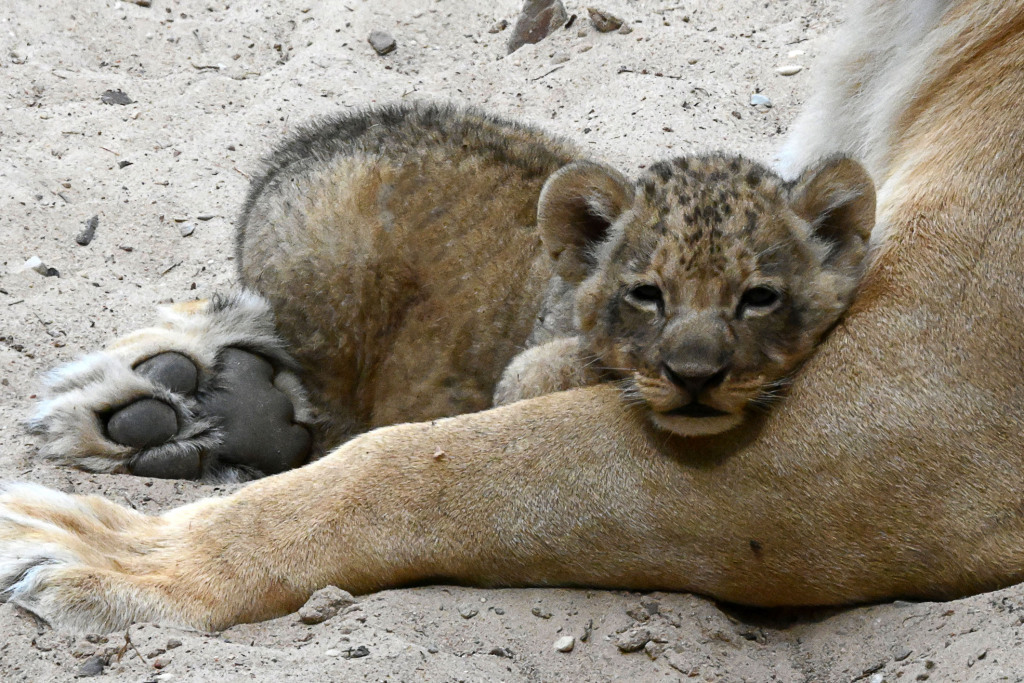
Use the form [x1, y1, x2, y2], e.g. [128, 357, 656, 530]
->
[0, 0, 1024, 683]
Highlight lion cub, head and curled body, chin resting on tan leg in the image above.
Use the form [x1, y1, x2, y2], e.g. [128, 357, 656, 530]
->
[237, 103, 873, 444]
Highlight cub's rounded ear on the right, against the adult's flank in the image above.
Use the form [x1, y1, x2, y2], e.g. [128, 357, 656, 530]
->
[790, 157, 874, 274]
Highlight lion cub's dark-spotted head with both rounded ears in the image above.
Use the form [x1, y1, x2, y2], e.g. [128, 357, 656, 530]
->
[539, 156, 874, 435]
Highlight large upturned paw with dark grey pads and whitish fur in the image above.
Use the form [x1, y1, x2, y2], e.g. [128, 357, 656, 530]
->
[29, 292, 312, 479]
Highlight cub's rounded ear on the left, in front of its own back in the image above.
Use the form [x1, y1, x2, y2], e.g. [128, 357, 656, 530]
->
[537, 161, 633, 283]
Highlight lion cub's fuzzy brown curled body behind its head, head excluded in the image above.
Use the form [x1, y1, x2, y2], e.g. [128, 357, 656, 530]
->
[238, 101, 579, 445]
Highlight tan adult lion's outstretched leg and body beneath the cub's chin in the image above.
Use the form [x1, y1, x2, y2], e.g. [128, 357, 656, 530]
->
[0, 0, 1024, 629]
